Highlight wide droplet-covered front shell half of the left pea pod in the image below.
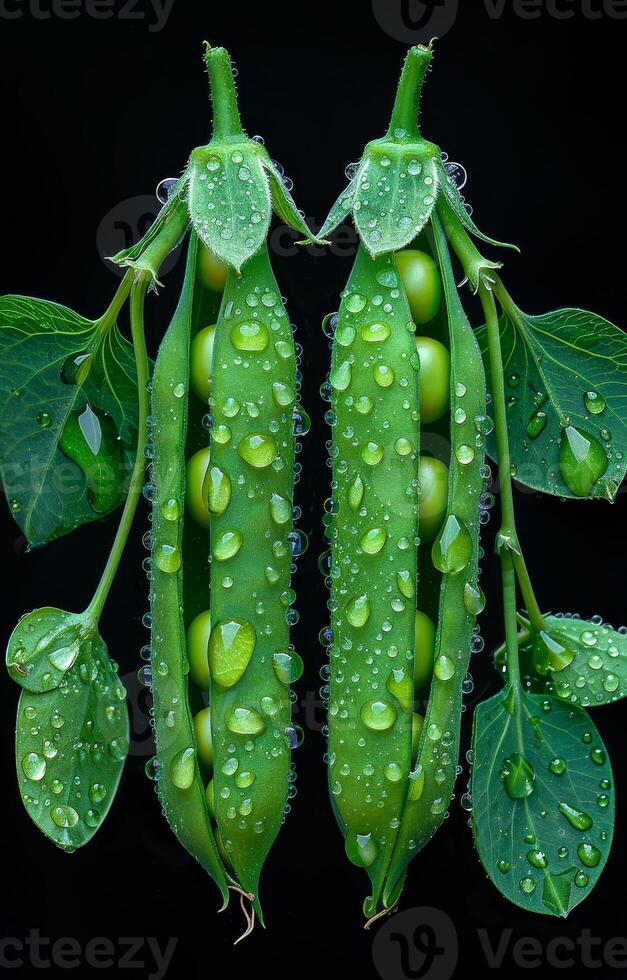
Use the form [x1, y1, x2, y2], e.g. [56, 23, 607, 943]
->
[207, 246, 298, 913]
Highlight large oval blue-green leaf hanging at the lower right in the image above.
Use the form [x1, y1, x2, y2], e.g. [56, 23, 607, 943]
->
[471, 688, 614, 917]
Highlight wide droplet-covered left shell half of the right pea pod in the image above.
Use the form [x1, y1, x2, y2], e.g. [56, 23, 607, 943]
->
[329, 248, 420, 920]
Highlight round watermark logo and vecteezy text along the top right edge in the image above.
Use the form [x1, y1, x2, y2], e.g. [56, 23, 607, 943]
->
[372, 0, 627, 44]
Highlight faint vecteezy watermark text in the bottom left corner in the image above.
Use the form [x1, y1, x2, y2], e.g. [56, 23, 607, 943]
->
[0, 929, 178, 980]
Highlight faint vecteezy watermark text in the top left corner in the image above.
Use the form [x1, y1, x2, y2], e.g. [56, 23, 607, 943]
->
[0, 0, 175, 33]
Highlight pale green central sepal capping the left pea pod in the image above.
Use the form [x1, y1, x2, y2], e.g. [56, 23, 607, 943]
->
[188, 142, 272, 272]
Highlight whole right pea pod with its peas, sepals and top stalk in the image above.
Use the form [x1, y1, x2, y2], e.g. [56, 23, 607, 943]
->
[321, 47, 490, 918]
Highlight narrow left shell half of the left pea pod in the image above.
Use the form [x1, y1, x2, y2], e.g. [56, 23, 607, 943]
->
[151, 233, 231, 905]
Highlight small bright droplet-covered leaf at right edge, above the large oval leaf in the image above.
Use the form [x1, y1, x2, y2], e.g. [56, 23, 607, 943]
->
[521, 615, 627, 708]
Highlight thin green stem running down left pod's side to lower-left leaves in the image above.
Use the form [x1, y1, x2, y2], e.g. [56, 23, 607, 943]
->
[85, 273, 151, 623]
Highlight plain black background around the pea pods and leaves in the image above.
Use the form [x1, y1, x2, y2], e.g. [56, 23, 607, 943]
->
[0, 0, 627, 980]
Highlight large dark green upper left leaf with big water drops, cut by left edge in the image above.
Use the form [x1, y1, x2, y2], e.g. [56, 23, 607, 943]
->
[0, 296, 137, 545]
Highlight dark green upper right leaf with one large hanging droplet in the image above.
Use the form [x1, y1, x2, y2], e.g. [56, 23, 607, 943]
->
[478, 304, 627, 501]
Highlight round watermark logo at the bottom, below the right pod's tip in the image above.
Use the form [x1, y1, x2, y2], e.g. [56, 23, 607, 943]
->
[372, 908, 458, 980]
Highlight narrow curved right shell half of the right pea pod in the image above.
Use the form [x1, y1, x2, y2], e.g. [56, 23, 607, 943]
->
[383, 216, 486, 908]
